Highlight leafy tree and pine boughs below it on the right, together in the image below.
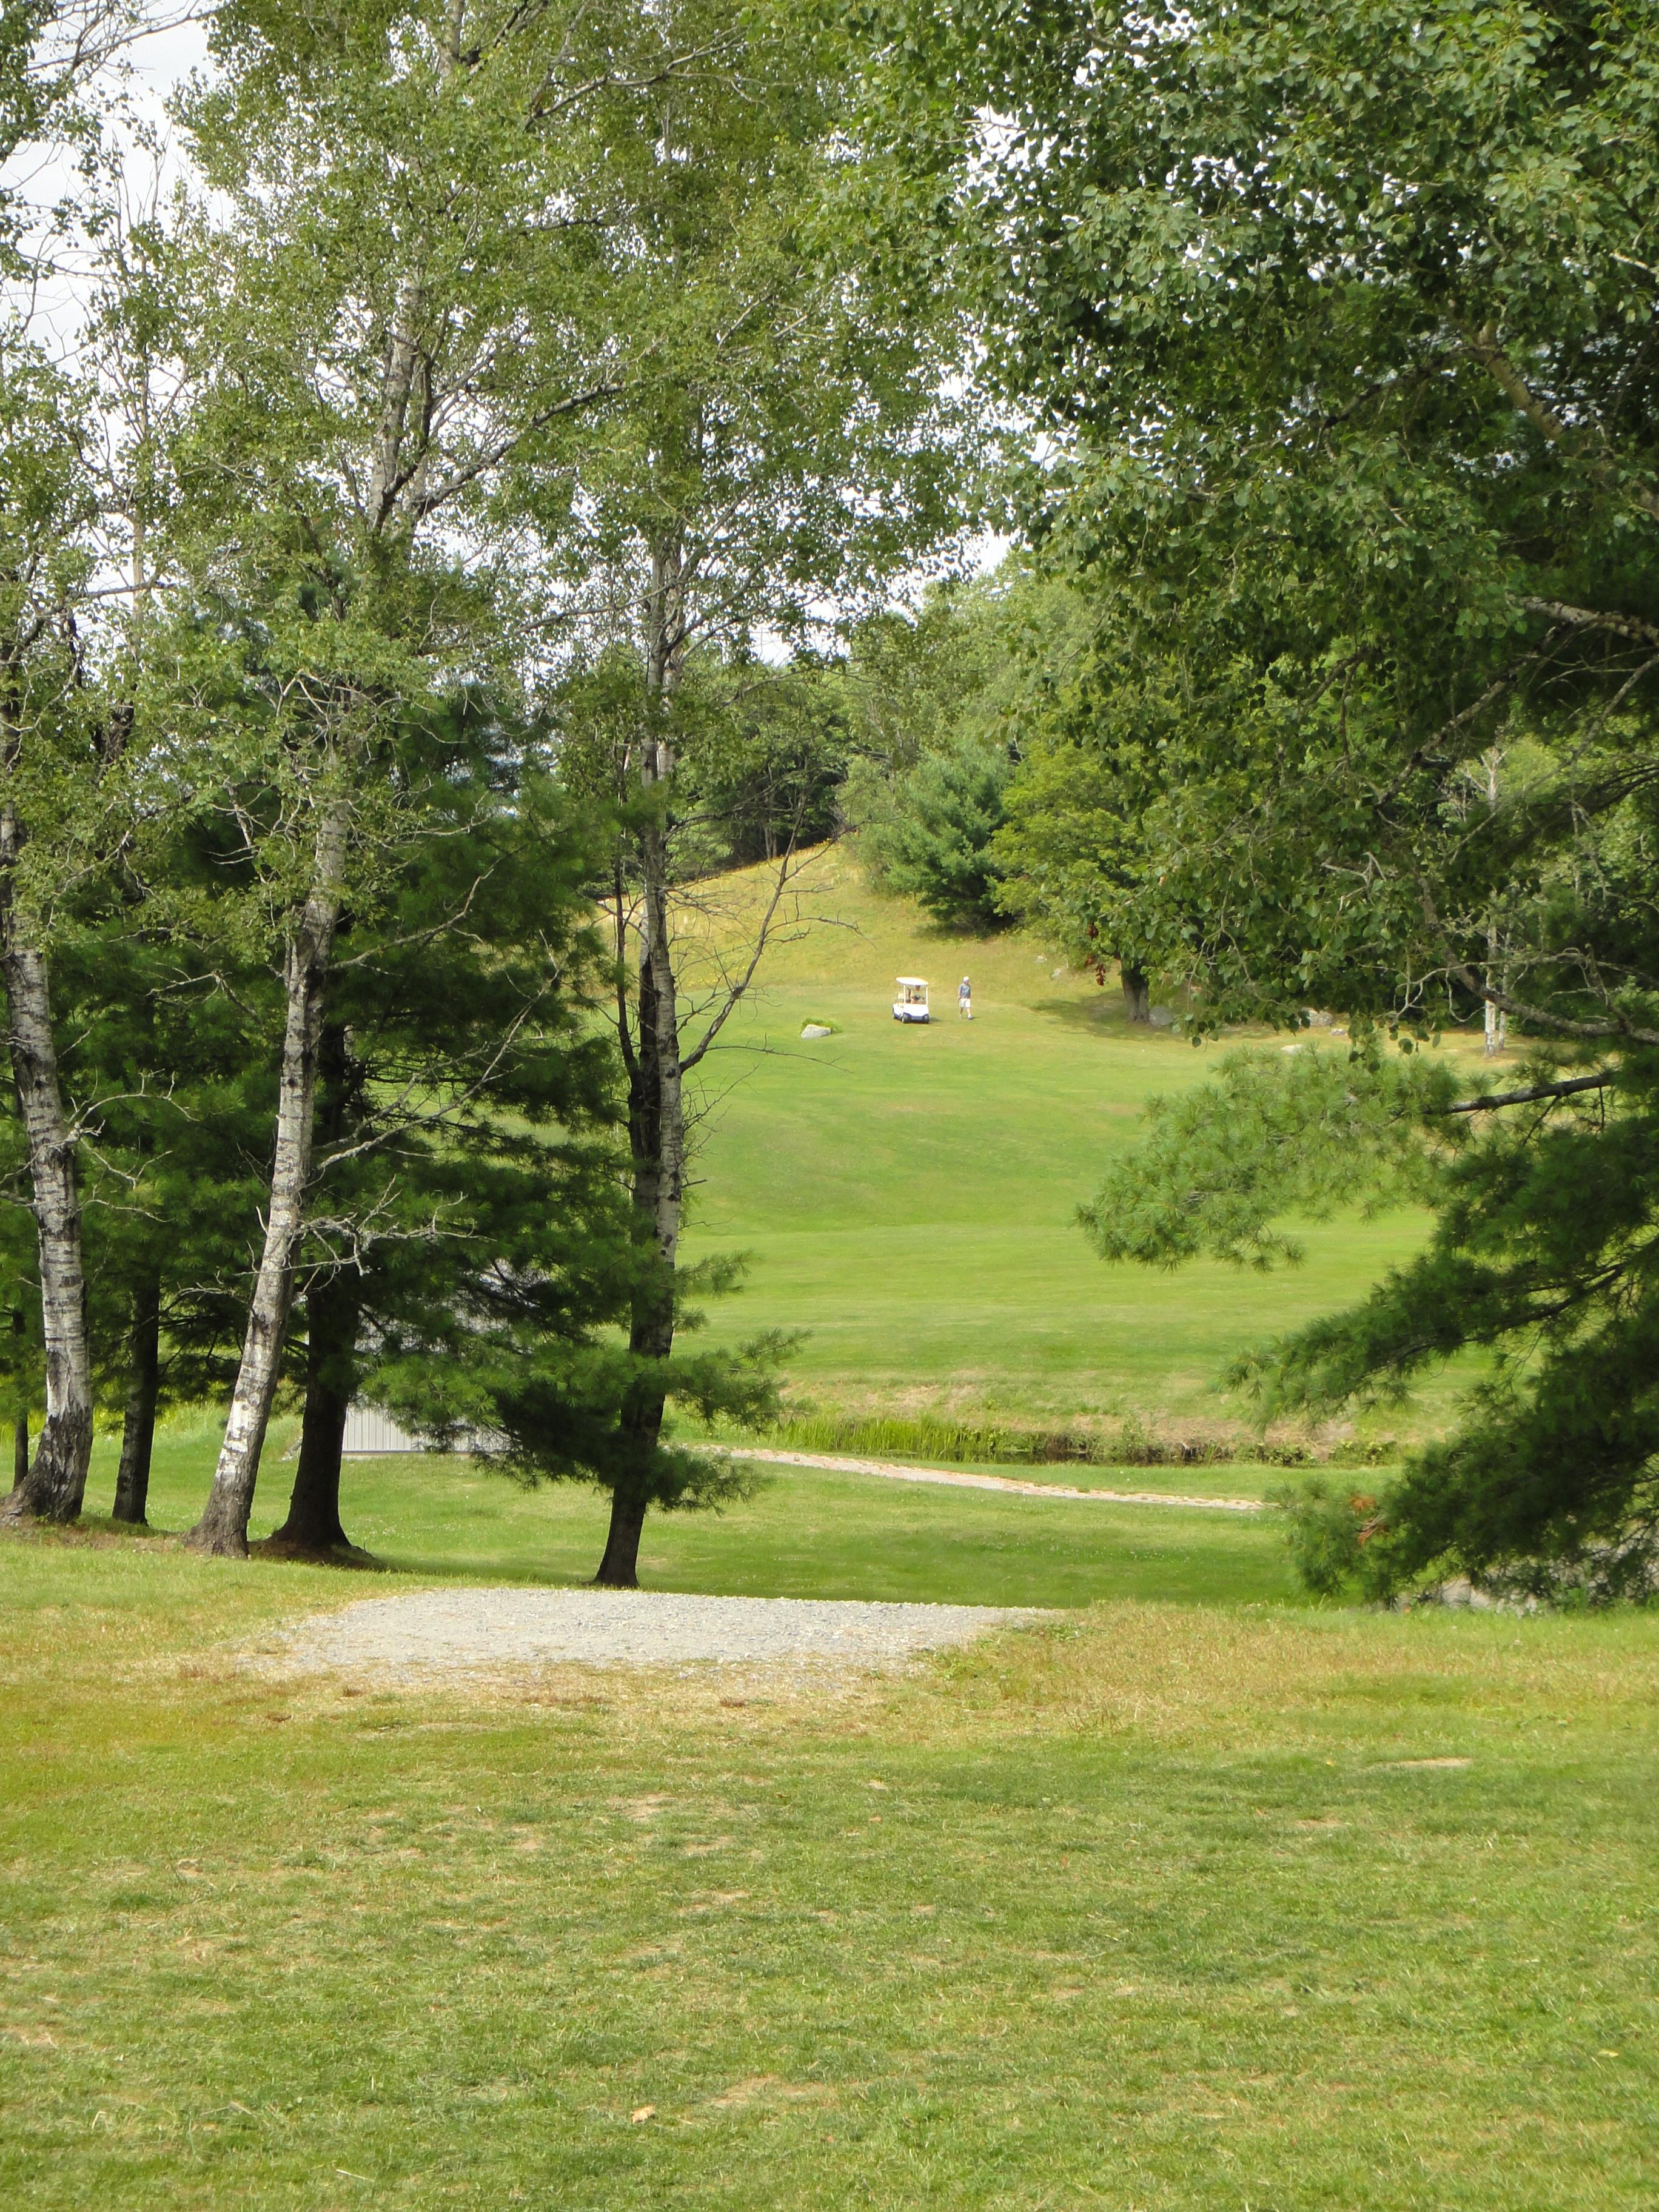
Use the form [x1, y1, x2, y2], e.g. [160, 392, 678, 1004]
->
[887, 0, 1659, 1588]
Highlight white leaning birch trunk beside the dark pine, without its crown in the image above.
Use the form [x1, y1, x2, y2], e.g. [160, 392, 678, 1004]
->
[186, 799, 349, 1560]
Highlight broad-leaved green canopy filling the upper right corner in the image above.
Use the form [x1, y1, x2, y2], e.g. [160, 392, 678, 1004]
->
[907, 0, 1659, 1040]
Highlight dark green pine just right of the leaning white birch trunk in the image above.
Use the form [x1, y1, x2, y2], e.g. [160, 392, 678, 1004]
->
[266, 721, 632, 1557]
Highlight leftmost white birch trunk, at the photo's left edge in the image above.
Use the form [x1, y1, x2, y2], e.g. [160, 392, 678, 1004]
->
[0, 827, 93, 1522]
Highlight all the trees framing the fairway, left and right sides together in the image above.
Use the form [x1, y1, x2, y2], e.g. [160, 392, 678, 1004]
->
[0, 0, 1659, 1610]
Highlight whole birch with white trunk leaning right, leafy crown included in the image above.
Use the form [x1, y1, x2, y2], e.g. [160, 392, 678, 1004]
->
[176, 0, 650, 1553]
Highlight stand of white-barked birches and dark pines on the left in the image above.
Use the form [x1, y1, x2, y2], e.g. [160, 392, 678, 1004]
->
[0, 0, 967, 1584]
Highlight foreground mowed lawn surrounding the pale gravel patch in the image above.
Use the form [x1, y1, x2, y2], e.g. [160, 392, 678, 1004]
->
[0, 1521, 1659, 2212]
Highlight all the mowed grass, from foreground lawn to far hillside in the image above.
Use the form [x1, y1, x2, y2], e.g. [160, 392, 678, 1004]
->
[0, 860, 1659, 2212]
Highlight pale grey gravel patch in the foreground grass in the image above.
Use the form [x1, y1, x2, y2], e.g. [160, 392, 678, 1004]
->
[286, 1588, 1042, 1675]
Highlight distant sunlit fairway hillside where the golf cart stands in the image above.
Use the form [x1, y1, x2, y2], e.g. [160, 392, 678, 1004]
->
[688, 851, 1486, 1431]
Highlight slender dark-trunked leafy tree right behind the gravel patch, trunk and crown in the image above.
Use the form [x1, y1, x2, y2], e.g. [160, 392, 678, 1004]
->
[533, 0, 965, 1586]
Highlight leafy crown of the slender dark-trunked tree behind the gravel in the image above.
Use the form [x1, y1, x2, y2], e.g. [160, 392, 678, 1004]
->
[526, 0, 973, 663]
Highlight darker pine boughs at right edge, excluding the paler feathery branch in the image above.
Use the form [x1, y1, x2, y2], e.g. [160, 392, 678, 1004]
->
[1254, 1055, 1659, 1588]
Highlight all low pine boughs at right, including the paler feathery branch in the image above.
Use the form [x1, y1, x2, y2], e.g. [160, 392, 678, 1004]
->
[1084, 1051, 1659, 1588]
